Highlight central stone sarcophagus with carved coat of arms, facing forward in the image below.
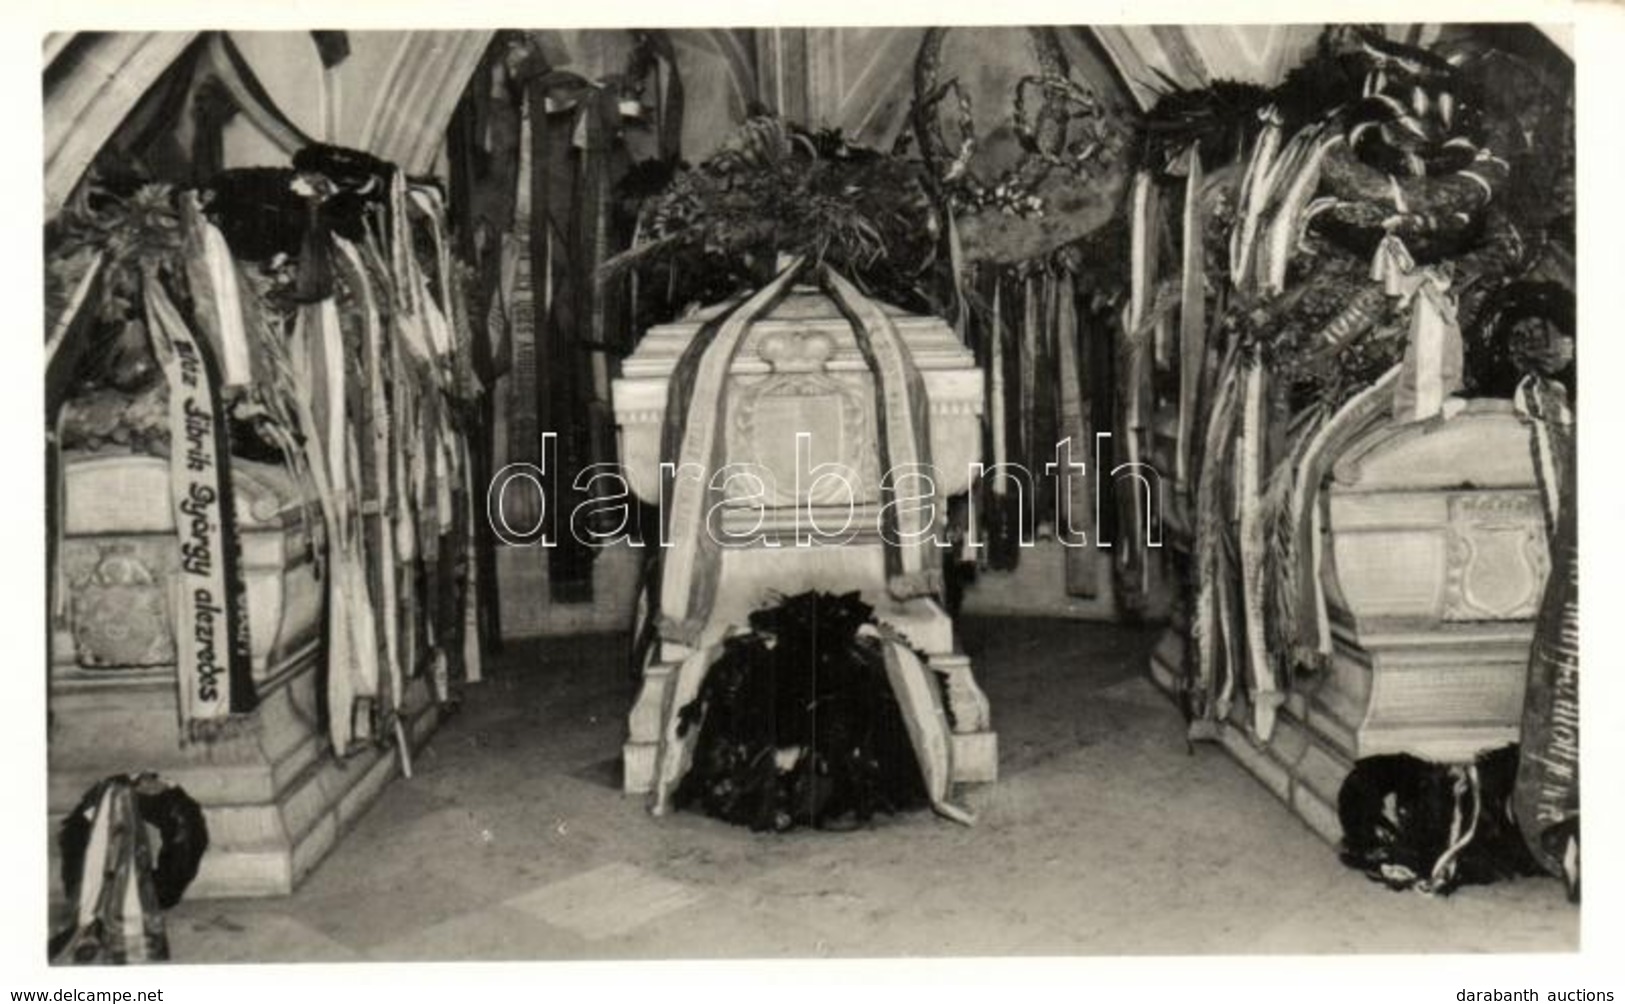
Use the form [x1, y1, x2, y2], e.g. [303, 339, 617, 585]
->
[614, 286, 998, 793]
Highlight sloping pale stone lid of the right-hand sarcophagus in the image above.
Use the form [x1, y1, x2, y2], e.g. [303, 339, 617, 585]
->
[1329, 398, 1536, 496]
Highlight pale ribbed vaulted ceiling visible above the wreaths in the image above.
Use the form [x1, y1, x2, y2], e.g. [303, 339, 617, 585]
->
[44, 24, 1567, 216]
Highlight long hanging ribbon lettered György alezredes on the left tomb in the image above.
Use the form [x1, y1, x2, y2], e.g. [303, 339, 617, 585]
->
[141, 273, 255, 739]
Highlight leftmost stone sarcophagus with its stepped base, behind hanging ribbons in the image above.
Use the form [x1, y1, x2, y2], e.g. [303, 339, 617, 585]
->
[47, 457, 439, 898]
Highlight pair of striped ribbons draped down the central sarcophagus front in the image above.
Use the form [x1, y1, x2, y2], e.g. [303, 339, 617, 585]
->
[658, 258, 943, 647]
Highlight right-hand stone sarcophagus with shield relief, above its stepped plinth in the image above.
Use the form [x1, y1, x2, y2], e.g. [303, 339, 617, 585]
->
[1307, 400, 1550, 760]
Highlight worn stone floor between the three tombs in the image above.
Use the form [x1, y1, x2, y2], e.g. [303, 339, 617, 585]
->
[158, 617, 1580, 962]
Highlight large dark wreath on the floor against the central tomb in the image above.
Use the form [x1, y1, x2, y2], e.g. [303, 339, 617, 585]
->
[674, 591, 926, 832]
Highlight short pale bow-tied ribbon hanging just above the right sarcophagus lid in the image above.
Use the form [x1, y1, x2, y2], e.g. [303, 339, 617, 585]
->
[1372, 234, 1463, 422]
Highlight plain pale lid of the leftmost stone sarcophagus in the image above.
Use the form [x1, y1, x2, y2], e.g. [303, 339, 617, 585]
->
[62, 453, 306, 536]
